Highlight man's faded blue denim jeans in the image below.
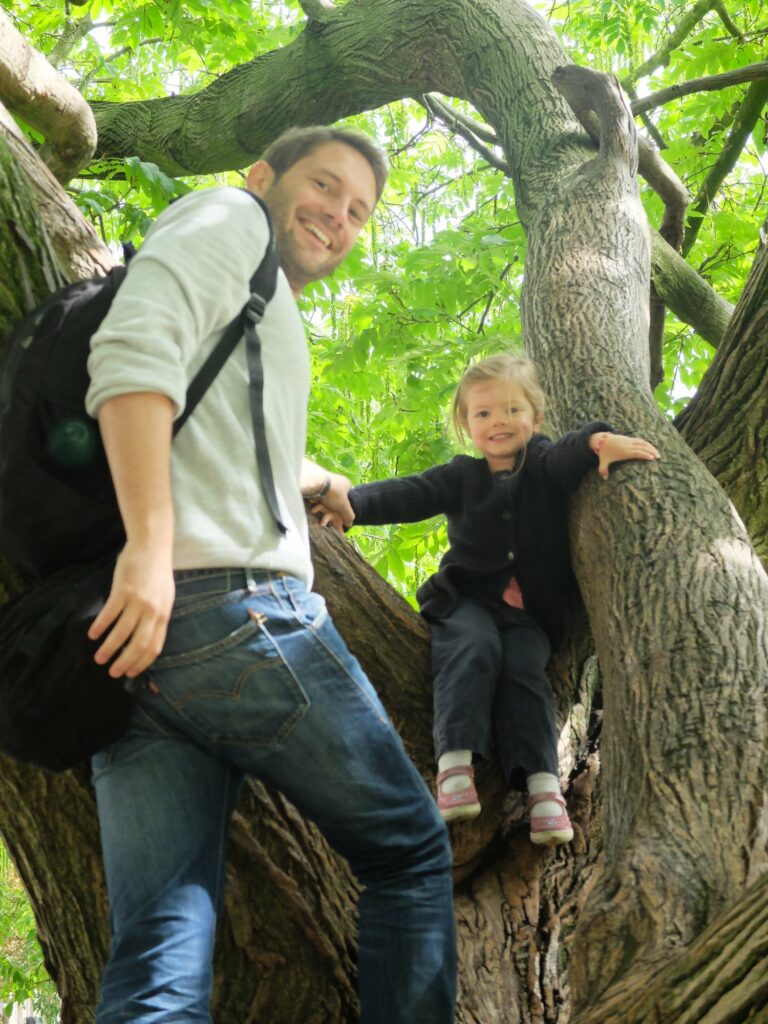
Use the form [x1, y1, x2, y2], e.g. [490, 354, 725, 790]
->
[93, 569, 456, 1024]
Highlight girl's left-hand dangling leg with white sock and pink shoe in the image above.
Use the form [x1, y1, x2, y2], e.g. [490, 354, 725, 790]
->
[430, 598, 502, 820]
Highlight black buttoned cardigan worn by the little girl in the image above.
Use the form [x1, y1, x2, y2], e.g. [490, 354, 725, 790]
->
[349, 422, 611, 639]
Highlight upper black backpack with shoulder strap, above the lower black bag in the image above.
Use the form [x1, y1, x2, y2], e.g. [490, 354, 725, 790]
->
[0, 193, 278, 578]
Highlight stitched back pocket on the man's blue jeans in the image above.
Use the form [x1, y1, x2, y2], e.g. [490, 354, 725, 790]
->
[150, 612, 309, 750]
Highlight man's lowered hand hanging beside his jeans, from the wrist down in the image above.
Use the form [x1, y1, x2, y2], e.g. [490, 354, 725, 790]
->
[88, 542, 175, 679]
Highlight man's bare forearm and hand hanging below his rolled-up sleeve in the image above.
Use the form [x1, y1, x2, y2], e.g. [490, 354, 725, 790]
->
[88, 391, 174, 679]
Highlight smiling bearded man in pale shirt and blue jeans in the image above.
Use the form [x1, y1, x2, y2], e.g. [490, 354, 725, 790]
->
[83, 128, 455, 1024]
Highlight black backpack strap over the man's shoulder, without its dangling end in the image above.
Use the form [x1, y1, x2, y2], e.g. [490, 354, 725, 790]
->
[173, 190, 280, 437]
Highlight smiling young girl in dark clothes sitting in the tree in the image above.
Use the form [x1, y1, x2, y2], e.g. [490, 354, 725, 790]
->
[324, 355, 658, 844]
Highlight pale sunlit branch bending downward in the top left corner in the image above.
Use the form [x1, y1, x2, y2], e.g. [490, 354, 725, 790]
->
[0, 11, 96, 183]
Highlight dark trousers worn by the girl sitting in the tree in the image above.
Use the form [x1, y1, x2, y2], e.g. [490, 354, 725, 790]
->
[429, 595, 558, 788]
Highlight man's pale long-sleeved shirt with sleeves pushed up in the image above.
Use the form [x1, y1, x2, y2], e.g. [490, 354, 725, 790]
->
[86, 187, 312, 587]
